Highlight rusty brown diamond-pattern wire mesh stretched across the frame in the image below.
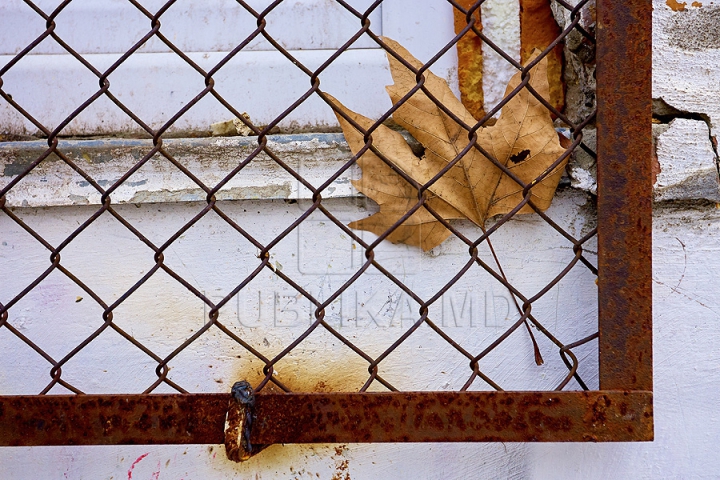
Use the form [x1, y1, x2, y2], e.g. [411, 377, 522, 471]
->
[0, 0, 597, 394]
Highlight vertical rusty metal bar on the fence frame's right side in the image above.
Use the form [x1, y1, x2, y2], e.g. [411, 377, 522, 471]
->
[597, 0, 652, 390]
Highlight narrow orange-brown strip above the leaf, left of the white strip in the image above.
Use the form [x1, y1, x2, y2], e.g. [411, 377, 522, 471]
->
[453, 0, 485, 119]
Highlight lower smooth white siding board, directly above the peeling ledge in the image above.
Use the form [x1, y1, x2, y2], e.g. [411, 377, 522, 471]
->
[0, 49, 391, 135]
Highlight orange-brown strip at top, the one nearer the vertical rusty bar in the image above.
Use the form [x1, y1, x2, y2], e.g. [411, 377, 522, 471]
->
[520, 0, 565, 111]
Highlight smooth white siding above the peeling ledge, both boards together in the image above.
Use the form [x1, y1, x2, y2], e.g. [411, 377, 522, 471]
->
[0, 0, 464, 135]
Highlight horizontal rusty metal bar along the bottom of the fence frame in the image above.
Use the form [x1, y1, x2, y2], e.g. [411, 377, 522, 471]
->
[0, 391, 653, 446]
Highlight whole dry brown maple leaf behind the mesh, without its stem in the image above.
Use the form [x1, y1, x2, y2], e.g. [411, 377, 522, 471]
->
[332, 38, 567, 250]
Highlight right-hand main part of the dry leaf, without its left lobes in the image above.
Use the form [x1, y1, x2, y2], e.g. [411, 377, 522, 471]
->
[383, 38, 567, 225]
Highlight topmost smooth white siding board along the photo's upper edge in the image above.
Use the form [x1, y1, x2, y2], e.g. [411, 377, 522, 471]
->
[0, 0, 382, 55]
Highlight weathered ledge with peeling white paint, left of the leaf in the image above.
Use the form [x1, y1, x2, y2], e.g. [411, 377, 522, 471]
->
[0, 134, 360, 207]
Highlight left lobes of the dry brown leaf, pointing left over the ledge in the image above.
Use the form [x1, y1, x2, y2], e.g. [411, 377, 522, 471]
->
[326, 94, 464, 250]
